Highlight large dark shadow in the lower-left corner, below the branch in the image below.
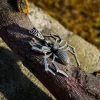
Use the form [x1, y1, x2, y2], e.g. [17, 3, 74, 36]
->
[0, 47, 51, 100]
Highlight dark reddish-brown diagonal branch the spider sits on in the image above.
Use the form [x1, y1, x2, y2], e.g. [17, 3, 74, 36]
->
[0, 0, 100, 100]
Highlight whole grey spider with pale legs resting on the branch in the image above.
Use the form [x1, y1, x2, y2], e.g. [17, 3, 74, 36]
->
[29, 28, 80, 77]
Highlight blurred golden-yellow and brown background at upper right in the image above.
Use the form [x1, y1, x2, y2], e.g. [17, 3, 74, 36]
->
[31, 0, 100, 48]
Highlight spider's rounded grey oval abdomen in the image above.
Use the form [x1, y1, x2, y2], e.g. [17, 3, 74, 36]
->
[55, 49, 69, 65]
